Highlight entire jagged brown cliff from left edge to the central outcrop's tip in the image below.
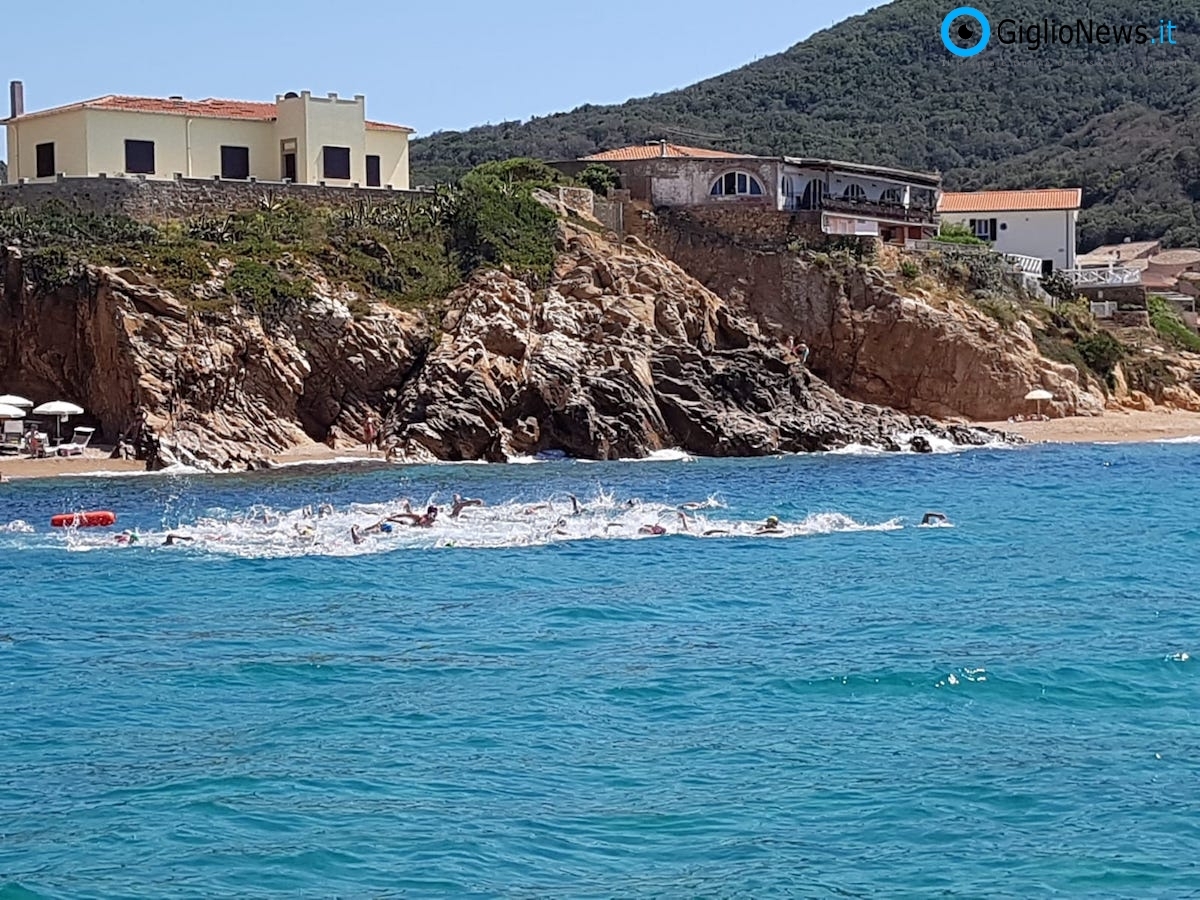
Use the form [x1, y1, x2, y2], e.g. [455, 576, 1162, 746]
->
[0, 221, 1012, 468]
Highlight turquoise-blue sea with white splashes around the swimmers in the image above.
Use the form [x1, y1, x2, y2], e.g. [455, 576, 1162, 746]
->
[0, 444, 1200, 898]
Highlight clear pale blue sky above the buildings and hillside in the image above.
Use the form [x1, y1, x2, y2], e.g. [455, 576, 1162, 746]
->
[0, 0, 880, 156]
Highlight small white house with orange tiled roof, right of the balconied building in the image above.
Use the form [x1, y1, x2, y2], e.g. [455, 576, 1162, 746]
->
[938, 187, 1084, 275]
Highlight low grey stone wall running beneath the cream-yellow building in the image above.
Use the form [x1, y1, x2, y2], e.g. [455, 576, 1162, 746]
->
[0, 178, 428, 222]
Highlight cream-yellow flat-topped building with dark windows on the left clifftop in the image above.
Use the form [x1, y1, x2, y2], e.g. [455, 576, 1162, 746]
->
[5, 82, 413, 190]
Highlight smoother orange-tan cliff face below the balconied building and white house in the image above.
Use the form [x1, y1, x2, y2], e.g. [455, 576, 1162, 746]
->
[650, 220, 1105, 421]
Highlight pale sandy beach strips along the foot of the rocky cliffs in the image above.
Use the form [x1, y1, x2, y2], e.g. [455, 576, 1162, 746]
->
[0, 408, 1200, 481]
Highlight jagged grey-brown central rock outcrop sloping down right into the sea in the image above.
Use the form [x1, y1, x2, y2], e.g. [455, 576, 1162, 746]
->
[388, 227, 1008, 460]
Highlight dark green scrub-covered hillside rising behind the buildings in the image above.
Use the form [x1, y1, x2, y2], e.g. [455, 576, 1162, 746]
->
[413, 0, 1200, 254]
